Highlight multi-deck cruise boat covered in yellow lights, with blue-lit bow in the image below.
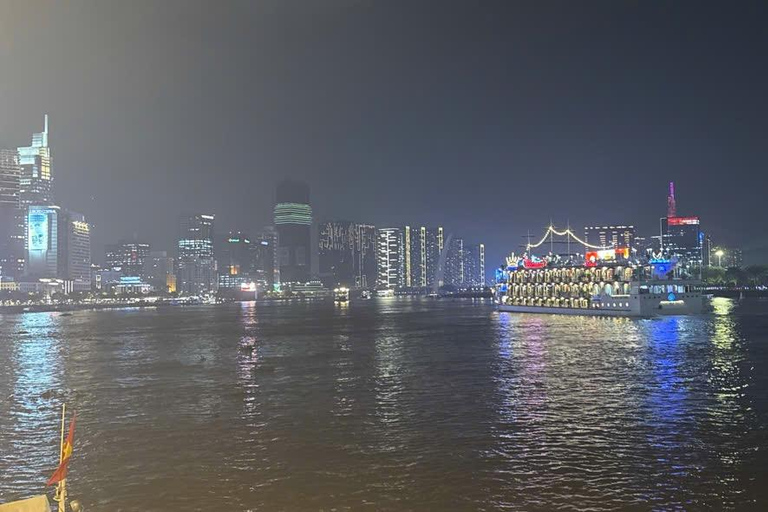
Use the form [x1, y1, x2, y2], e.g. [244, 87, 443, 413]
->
[495, 241, 704, 317]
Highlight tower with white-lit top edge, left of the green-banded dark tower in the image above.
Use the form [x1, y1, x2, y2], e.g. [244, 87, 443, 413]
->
[176, 213, 216, 295]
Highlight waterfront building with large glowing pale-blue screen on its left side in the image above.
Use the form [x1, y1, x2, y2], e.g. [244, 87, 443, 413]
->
[27, 205, 91, 291]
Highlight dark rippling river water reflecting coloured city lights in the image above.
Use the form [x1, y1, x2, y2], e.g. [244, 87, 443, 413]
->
[0, 298, 768, 512]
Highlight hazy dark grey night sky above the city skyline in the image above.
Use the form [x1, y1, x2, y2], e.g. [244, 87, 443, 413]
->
[0, 0, 768, 266]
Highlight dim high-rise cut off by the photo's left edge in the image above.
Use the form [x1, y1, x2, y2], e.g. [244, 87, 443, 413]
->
[0, 149, 24, 279]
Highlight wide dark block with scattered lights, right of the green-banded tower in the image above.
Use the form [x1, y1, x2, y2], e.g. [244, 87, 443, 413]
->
[318, 221, 377, 288]
